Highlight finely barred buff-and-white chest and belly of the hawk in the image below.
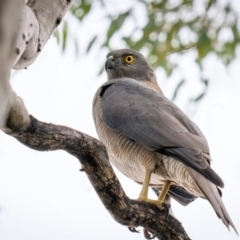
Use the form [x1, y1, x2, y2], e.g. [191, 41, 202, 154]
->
[93, 94, 165, 184]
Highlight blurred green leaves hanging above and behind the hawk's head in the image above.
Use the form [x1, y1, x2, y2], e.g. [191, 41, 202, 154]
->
[55, 0, 240, 102]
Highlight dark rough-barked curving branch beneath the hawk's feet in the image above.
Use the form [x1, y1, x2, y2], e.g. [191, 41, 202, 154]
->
[7, 116, 190, 240]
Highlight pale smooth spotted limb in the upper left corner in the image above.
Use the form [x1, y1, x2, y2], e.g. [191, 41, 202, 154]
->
[12, 0, 74, 69]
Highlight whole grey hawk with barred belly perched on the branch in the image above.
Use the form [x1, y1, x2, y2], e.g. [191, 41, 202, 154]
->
[93, 49, 237, 233]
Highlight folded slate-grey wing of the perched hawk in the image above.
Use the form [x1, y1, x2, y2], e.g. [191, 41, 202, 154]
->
[100, 78, 223, 187]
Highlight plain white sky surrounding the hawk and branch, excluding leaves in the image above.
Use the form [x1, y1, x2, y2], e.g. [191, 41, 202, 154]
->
[0, 0, 240, 240]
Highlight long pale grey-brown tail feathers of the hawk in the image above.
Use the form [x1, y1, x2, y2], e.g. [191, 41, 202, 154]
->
[188, 167, 238, 235]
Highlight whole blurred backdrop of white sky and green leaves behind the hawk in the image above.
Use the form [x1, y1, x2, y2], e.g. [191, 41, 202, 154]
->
[0, 0, 240, 240]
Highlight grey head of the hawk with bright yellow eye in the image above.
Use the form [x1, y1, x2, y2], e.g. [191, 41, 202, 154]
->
[105, 49, 156, 84]
